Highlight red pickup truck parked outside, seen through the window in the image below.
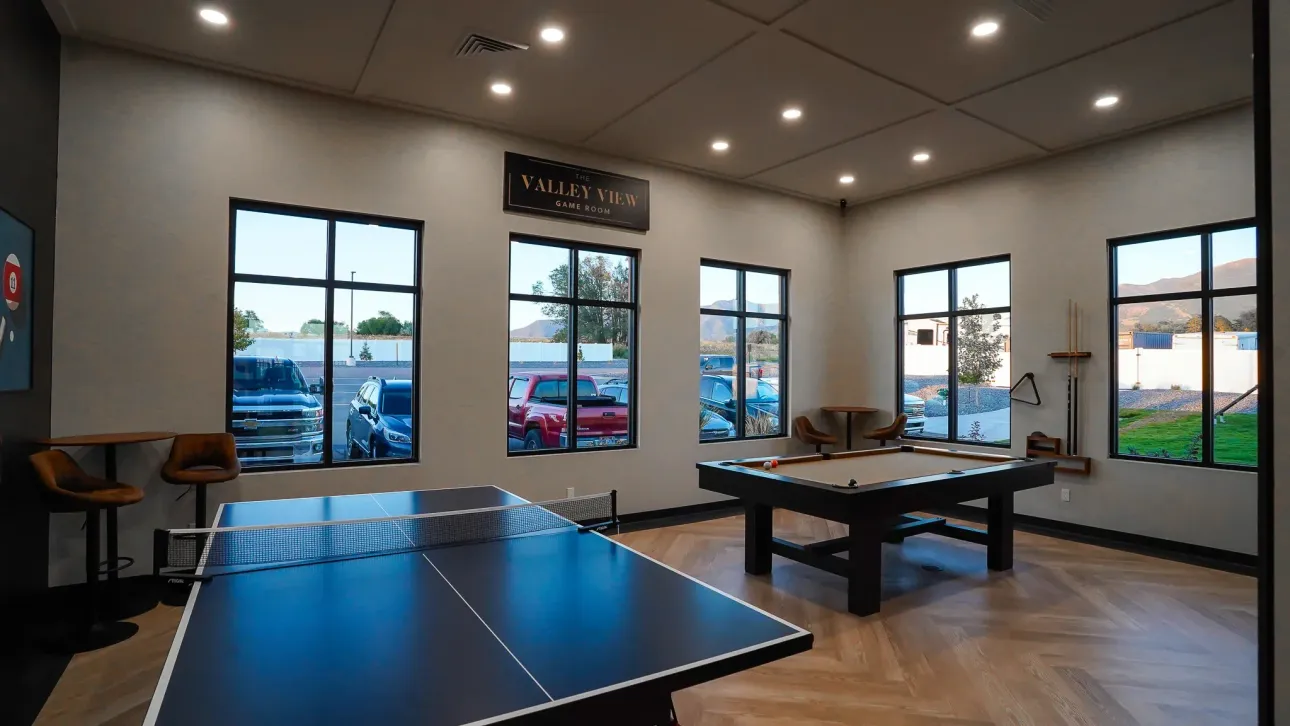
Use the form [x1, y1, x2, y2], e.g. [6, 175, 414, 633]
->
[507, 373, 628, 451]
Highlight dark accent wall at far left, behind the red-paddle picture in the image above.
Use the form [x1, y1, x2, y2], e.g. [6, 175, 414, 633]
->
[0, 0, 59, 603]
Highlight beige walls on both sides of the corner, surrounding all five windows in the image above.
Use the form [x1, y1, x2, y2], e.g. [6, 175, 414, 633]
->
[50, 38, 1259, 584]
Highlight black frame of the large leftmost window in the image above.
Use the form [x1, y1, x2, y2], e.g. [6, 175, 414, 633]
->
[224, 197, 426, 472]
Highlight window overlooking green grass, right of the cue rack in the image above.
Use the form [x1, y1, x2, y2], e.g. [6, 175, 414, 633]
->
[1109, 221, 1259, 468]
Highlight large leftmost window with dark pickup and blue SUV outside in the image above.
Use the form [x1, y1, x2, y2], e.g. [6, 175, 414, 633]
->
[227, 200, 422, 468]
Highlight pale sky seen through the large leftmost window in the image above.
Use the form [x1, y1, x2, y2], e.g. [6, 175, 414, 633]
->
[233, 210, 417, 333]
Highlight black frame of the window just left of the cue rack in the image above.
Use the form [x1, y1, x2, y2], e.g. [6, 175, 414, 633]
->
[895, 254, 1013, 449]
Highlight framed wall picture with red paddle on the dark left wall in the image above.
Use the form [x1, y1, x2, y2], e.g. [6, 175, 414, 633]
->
[0, 210, 34, 392]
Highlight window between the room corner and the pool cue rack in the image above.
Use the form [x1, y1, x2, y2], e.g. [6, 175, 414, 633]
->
[895, 257, 1013, 446]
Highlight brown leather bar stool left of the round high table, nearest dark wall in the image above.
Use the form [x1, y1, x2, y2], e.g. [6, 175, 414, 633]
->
[31, 450, 143, 650]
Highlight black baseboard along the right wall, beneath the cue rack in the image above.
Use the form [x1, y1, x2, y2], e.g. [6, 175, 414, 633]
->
[930, 504, 1259, 578]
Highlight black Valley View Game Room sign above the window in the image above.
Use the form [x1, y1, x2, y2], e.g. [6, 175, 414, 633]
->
[502, 151, 649, 232]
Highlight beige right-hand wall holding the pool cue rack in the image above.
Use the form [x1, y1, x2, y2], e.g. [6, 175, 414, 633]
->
[837, 108, 1256, 553]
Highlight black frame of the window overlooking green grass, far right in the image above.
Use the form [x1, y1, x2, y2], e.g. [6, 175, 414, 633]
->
[1107, 218, 1268, 472]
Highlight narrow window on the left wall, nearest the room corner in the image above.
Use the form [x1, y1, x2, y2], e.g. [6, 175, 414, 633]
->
[699, 260, 788, 441]
